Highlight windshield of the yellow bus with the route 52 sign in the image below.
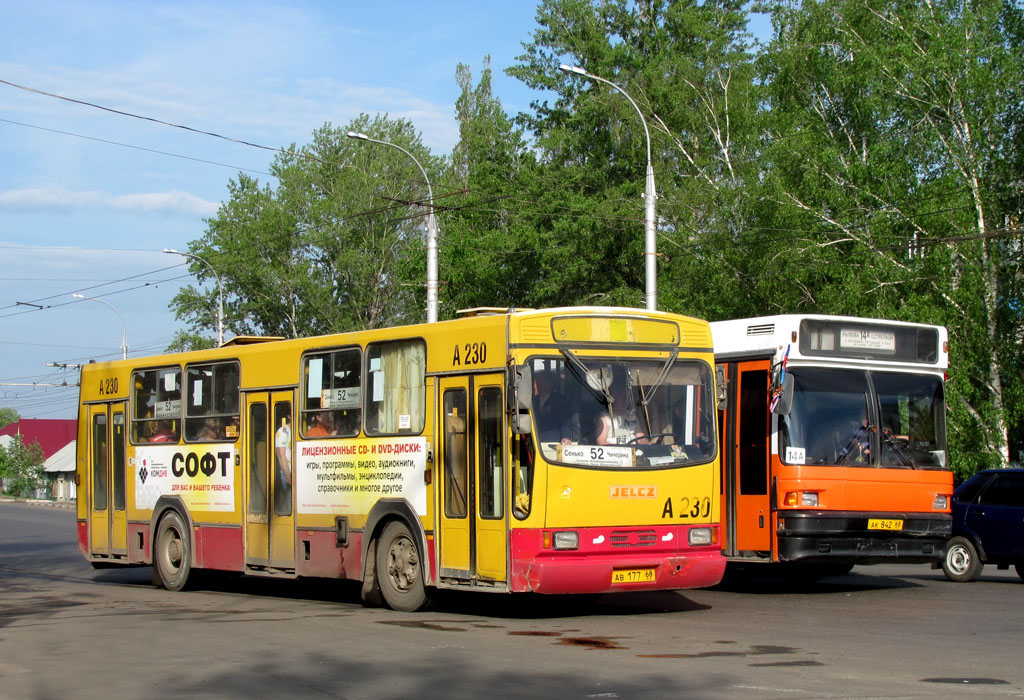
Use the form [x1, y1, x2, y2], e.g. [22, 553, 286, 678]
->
[530, 352, 716, 469]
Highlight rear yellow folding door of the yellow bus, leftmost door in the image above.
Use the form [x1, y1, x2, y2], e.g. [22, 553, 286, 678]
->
[88, 403, 128, 557]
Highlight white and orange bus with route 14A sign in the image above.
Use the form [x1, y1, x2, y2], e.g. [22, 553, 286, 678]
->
[711, 315, 952, 576]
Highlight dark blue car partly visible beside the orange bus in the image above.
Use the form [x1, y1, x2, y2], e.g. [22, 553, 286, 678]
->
[942, 469, 1024, 581]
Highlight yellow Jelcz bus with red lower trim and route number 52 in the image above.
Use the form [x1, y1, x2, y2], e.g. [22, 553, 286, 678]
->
[77, 307, 725, 610]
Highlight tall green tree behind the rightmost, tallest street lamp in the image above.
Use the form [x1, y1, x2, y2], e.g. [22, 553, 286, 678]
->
[509, 0, 758, 316]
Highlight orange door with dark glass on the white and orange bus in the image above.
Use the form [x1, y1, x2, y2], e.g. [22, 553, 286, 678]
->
[722, 359, 772, 557]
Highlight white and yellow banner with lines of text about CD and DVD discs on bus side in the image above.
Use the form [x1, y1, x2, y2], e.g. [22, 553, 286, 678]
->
[295, 437, 427, 516]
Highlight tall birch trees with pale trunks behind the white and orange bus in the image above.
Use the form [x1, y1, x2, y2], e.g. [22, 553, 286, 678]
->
[743, 0, 1024, 473]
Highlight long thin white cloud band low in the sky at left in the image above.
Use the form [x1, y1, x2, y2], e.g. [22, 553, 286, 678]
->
[0, 187, 220, 217]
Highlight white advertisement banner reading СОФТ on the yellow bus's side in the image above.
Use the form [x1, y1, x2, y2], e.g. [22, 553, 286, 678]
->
[132, 444, 234, 511]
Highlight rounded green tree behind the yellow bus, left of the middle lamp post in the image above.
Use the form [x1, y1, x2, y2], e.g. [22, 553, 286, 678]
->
[171, 115, 439, 347]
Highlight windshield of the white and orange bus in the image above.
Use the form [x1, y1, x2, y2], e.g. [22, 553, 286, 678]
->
[779, 367, 947, 469]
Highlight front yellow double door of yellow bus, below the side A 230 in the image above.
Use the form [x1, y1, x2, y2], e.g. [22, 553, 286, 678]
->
[436, 375, 509, 585]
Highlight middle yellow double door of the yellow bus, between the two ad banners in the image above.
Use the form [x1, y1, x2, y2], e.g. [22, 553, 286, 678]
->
[245, 391, 295, 570]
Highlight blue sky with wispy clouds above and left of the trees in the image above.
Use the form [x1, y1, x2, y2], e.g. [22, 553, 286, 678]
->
[0, 0, 770, 418]
